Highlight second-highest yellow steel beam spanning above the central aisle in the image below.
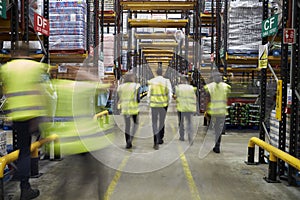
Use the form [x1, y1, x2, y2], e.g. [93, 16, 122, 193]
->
[128, 19, 188, 28]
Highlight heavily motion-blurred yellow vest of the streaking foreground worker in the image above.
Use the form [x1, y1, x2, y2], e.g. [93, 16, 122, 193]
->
[43, 79, 113, 156]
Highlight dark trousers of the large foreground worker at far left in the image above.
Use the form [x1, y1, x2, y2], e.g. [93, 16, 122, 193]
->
[13, 118, 39, 189]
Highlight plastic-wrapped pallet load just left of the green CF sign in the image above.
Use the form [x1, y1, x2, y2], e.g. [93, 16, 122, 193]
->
[228, 0, 262, 54]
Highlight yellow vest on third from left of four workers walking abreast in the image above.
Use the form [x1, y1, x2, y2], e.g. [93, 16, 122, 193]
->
[175, 84, 196, 112]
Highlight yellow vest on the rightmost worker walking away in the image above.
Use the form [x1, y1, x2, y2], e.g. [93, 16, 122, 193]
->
[204, 82, 231, 115]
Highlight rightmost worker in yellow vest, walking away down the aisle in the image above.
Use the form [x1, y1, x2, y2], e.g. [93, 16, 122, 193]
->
[204, 71, 231, 153]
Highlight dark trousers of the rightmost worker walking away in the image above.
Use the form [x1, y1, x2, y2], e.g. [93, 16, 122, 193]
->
[210, 115, 226, 148]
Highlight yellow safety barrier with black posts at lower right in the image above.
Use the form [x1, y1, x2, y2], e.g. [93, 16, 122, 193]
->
[247, 137, 300, 182]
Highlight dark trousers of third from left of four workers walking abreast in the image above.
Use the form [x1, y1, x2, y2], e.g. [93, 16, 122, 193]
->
[178, 111, 193, 141]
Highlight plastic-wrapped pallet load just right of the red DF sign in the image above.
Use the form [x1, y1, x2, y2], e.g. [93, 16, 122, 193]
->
[49, 0, 87, 51]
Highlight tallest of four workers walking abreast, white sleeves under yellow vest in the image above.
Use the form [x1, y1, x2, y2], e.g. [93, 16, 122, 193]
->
[148, 63, 173, 150]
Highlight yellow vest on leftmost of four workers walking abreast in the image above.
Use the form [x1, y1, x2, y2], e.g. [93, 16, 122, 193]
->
[117, 83, 140, 115]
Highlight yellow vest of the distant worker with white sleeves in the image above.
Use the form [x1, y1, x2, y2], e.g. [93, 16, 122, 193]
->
[148, 77, 169, 107]
